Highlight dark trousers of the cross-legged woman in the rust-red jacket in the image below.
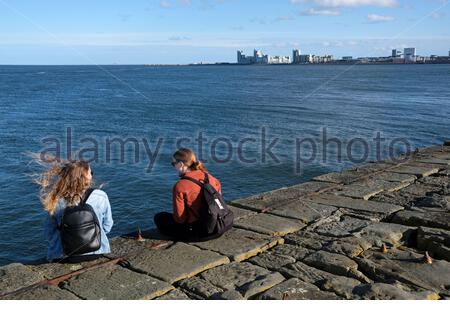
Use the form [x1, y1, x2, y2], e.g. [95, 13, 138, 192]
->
[153, 212, 221, 242]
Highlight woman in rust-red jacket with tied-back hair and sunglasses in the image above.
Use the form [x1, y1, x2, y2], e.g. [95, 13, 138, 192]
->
[154, 148, 221, 241]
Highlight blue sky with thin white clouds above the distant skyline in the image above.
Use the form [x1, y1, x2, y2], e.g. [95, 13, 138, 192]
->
[0, 0, 450, 64]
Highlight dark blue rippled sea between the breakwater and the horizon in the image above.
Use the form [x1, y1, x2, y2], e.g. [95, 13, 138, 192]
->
[0, 65, 450, 265]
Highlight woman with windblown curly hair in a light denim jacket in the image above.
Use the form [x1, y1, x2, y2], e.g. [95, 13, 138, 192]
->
[35, 160, 113, 263]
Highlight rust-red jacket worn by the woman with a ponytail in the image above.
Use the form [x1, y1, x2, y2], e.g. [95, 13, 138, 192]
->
[172, 170, 221, 223]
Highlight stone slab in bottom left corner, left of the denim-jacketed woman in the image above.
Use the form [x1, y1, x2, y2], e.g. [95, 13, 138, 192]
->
[0, 263, 44, 295]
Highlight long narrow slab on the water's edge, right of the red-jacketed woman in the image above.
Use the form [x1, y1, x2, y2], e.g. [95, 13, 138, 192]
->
[231, 181, 333, 211]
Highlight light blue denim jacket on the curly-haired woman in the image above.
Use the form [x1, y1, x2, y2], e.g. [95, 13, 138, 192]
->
[44, 189, 113, 261]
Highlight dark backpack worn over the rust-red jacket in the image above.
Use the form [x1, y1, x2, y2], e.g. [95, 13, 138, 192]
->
[182, 172, 233, 235]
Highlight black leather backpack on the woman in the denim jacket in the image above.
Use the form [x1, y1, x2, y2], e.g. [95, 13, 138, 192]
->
[58, 188, 101, 256]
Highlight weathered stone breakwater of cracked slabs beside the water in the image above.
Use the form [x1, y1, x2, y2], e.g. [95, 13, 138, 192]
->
[0, 142, 450, 300]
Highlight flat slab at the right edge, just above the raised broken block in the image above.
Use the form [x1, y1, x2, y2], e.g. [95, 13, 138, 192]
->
[392, 210, 450, 230]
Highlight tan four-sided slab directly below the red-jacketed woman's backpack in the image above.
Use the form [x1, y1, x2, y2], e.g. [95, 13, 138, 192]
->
[192, 228, 284, 261]
